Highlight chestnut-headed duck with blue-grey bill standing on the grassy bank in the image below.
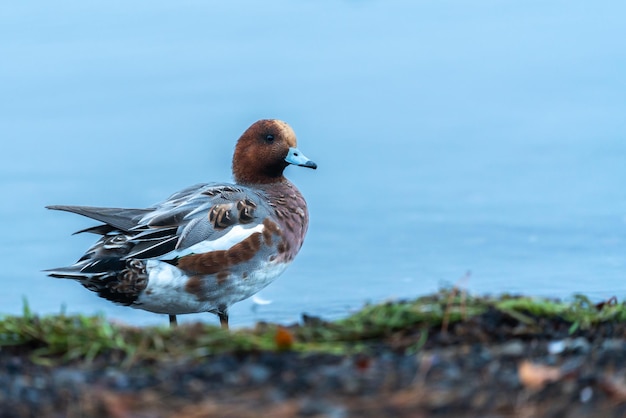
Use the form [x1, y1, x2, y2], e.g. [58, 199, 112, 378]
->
[45, 119, 317, 329]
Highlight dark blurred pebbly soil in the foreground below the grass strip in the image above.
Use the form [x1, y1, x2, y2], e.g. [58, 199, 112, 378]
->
[0, 310, 626, 418]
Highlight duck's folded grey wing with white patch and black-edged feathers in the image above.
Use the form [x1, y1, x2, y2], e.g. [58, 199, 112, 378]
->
[49, 183, 270, 260]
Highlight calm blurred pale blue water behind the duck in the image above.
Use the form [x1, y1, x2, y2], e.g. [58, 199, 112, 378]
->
[0, 0, 626, 325]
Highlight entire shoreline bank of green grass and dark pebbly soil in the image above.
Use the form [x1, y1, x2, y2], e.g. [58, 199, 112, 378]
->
[0, 289, 626, 417]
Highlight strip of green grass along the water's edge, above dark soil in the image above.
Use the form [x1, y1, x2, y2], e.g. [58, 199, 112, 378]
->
[0, 289, 626, 364]
